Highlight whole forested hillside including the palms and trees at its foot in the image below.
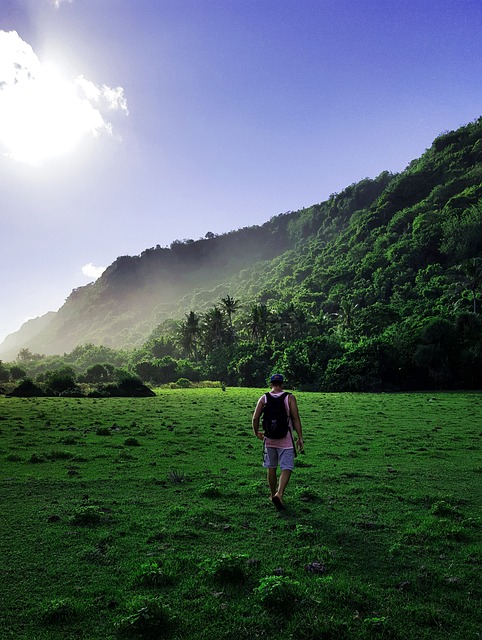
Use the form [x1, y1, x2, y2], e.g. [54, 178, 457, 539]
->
[0, 118, 482, 393]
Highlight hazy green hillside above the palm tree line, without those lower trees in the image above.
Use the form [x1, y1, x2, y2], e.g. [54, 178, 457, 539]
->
[0, 119, 482, 358]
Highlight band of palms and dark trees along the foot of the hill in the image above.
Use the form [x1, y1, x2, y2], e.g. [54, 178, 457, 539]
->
[0, 272, 482, 395]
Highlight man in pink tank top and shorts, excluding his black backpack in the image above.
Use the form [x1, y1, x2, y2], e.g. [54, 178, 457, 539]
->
[253, 373, 303, 511]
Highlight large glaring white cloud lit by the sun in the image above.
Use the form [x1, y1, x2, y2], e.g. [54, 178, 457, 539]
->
[0, 30, 128, 165]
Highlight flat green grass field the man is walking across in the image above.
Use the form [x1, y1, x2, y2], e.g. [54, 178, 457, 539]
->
[0, 388, 482, 640]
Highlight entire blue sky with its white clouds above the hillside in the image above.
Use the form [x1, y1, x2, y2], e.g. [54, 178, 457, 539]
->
[0, 0, 482, 348]
